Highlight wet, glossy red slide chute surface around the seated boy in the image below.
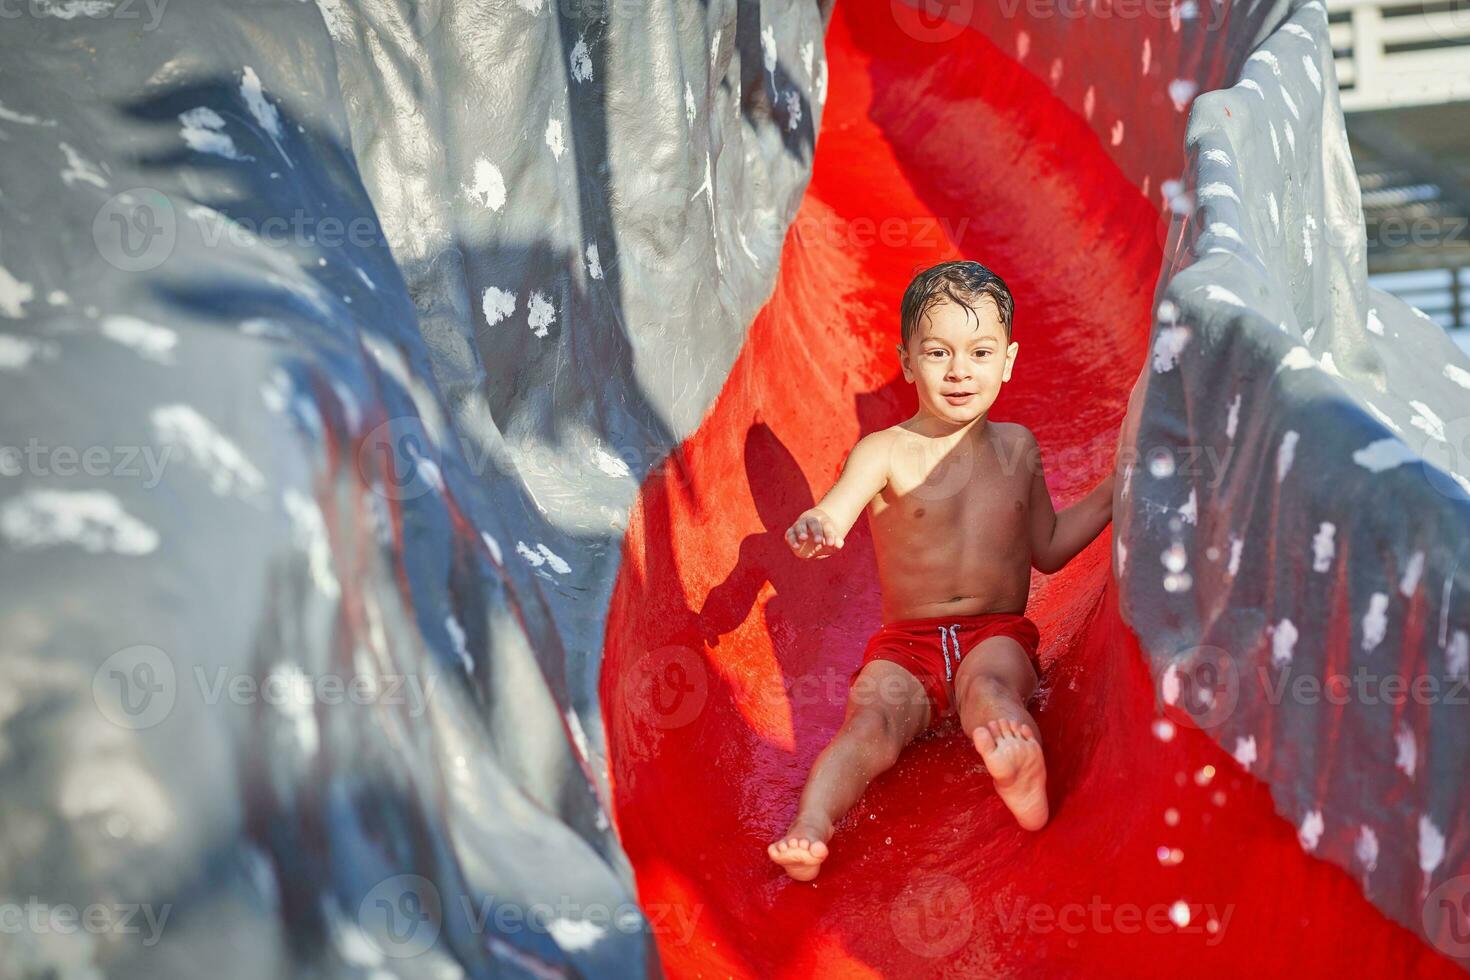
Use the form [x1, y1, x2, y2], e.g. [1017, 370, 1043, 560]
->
[601, 4, 1458, 977]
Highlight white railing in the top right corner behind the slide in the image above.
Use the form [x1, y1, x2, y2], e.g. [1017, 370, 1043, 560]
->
[1326, 0, 1470, 112]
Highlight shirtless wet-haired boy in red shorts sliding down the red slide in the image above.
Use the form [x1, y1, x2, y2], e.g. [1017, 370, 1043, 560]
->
[767, 262, 1113, 882]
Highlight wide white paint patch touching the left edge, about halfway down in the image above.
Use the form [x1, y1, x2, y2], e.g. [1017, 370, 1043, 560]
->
[0, 489, 159, 555]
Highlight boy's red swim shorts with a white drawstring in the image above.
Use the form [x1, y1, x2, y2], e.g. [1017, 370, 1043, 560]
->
[848, 613, 1041, 727]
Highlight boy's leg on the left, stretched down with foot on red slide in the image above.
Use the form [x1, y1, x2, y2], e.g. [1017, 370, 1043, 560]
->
[766, 660, 929, 882]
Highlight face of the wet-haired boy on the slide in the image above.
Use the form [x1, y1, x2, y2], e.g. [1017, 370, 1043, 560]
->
[898, 297, 1020, 425]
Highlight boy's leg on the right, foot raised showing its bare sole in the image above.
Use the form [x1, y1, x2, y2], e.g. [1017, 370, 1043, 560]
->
[954, 636, 1048, 830]
